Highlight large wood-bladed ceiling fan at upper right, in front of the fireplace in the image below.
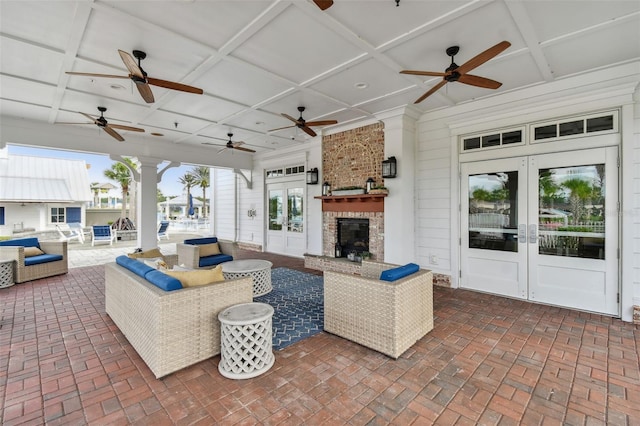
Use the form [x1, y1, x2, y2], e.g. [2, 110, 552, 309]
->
[400, 41, 511, 104]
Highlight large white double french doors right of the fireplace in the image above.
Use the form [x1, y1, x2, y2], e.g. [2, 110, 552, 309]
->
[460, 147, 619, 315]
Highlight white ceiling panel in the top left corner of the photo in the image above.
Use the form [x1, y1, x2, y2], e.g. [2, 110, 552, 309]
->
[0, 0, 77, 50]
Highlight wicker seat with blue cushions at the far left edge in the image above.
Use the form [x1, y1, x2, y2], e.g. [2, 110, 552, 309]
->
[0, 237, 69, 283]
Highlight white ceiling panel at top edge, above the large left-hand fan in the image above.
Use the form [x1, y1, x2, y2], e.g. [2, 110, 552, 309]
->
[102, 0, 270, 49]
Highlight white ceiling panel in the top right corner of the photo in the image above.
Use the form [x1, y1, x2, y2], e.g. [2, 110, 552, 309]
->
[522, 0, 640, 43]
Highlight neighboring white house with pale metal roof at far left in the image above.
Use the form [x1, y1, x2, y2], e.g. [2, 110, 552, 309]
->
[0, 148, 93, 235]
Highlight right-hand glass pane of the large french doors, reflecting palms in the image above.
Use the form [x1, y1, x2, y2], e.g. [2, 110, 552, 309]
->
[538, 164, 605, 259]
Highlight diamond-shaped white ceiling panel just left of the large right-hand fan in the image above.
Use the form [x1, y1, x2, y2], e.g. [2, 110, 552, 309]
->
[310, 59, 410, 105]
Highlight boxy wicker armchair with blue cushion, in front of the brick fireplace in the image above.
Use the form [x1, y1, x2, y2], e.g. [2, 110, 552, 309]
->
[324, 260, 433, 359]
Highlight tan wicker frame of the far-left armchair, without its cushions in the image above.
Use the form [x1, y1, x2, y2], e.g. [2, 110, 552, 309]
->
[0, 241, 69, 283]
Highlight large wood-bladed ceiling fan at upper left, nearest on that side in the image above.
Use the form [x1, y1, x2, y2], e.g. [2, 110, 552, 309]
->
[67, 50, 203, 104]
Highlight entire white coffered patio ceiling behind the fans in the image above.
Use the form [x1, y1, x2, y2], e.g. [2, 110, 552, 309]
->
[0, 0, 640, 157]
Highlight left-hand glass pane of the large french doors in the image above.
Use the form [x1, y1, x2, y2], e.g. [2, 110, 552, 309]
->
[469, 171, 518, 252]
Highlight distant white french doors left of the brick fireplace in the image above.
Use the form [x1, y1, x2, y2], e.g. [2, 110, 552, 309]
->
[266, 182, 306, 257]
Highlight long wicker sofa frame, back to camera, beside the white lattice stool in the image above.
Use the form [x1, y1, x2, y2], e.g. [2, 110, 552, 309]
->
[105, 263, 253, 378]
